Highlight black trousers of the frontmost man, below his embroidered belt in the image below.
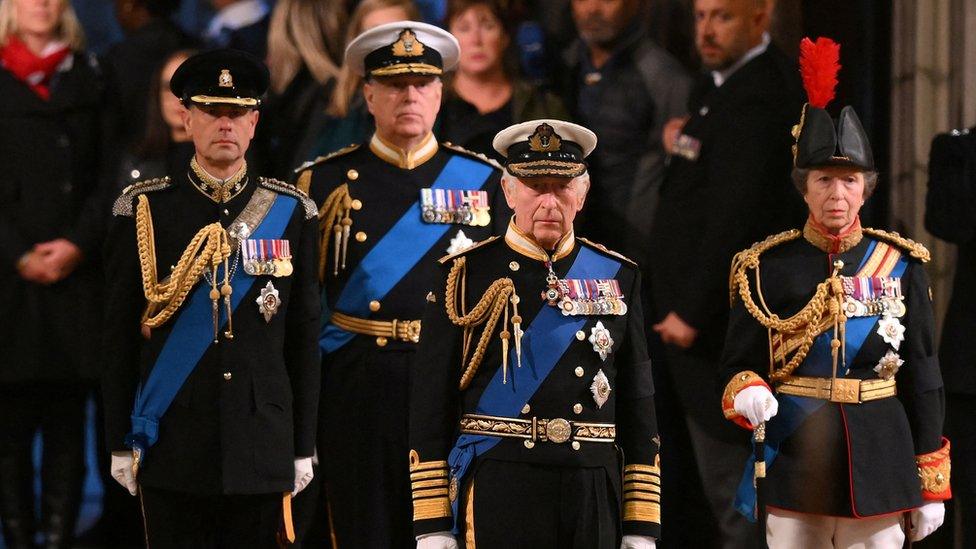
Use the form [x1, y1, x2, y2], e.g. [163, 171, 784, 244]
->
[458, 460, 621, 549]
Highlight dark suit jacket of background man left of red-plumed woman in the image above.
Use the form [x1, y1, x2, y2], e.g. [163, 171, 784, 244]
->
[649, 45, 806, 361]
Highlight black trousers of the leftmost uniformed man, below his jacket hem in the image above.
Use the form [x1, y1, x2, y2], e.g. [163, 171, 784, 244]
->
[140, 488, 281, 549]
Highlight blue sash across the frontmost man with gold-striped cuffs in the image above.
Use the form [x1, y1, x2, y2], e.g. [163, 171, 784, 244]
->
[447, 247, 620, 533]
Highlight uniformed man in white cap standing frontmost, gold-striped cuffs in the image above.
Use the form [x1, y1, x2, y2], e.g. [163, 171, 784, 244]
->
[410, 120, 661, 549]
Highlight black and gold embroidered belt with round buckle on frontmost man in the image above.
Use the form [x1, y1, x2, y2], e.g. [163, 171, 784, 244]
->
[460, 414, 617, 444]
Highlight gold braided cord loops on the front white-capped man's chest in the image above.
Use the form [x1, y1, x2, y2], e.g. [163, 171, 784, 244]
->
[444, 257, 518, 391]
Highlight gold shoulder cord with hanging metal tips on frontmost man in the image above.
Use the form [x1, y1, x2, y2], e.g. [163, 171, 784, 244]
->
[444, 257, 522, 391]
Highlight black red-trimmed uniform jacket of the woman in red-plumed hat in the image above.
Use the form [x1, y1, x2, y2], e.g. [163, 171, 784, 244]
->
[722, 222, 944, 517]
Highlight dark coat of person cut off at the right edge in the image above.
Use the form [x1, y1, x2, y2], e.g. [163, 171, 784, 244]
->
[925, 130, 976, 395]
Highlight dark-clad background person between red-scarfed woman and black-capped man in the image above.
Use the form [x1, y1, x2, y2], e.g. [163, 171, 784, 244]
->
[102, 0, 195, 148]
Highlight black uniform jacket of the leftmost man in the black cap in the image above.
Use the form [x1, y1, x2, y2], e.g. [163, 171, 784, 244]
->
[102, 170, 320, 494]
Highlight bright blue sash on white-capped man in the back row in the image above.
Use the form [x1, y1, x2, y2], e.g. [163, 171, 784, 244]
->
[319, 156, 494, 353]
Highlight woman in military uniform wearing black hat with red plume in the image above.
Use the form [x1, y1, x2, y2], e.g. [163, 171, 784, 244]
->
[722, 38, 950, 548]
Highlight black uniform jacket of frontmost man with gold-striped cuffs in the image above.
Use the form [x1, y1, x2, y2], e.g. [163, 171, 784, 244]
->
[410, 228, 660, 537]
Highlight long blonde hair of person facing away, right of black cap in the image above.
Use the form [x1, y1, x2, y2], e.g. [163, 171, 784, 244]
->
[268, 0, 346, 93]
